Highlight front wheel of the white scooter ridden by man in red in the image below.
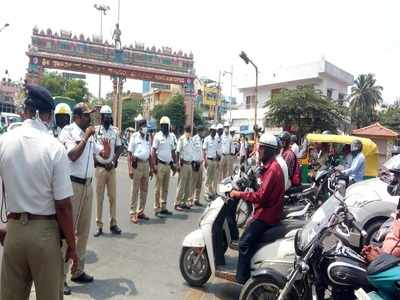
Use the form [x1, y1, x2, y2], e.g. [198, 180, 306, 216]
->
[179, 247, 211, 287]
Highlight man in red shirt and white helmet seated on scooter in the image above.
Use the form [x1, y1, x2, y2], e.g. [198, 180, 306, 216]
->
[230, 134, 285, 283]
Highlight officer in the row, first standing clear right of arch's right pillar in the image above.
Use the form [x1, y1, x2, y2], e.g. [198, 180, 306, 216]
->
[203, 125, 220, 196]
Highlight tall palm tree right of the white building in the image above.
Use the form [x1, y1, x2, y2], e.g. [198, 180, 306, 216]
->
[350, 73, 383, 128]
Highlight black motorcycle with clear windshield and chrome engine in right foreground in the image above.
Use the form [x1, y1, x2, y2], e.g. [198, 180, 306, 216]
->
[240, 188, 370, 300]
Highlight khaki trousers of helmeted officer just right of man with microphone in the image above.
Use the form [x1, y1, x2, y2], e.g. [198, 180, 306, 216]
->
[96, 167, 117, 228]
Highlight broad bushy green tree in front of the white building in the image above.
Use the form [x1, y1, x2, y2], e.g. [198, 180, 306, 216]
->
[265, 87, 346, 136]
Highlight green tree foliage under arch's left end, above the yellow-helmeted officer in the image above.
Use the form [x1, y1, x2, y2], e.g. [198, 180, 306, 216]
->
[40, 72, 89, 103]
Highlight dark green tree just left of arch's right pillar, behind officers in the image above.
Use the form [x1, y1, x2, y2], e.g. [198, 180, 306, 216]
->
[152, 94, 185, 132]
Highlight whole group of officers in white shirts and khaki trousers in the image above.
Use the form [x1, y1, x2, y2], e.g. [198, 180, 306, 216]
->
[0, 85, 244, 300]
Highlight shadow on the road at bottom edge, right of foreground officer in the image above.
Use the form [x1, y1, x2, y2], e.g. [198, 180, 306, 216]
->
[71, 278, 138, 300]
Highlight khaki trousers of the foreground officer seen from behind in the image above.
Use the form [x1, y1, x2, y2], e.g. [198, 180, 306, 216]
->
[1, 219, 64, 300]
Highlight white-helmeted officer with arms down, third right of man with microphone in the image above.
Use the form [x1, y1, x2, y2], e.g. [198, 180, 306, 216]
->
[152, 116, 176, 218]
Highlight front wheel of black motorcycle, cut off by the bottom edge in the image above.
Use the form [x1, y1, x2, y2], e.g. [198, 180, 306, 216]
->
[239, 276, 283, 300]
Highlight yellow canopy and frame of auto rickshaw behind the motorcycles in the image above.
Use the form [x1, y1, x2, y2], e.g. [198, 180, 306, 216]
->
[299, 133, 378, 182]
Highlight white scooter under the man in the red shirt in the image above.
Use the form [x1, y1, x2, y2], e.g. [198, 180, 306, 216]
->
[180, 172, 305, 287]
